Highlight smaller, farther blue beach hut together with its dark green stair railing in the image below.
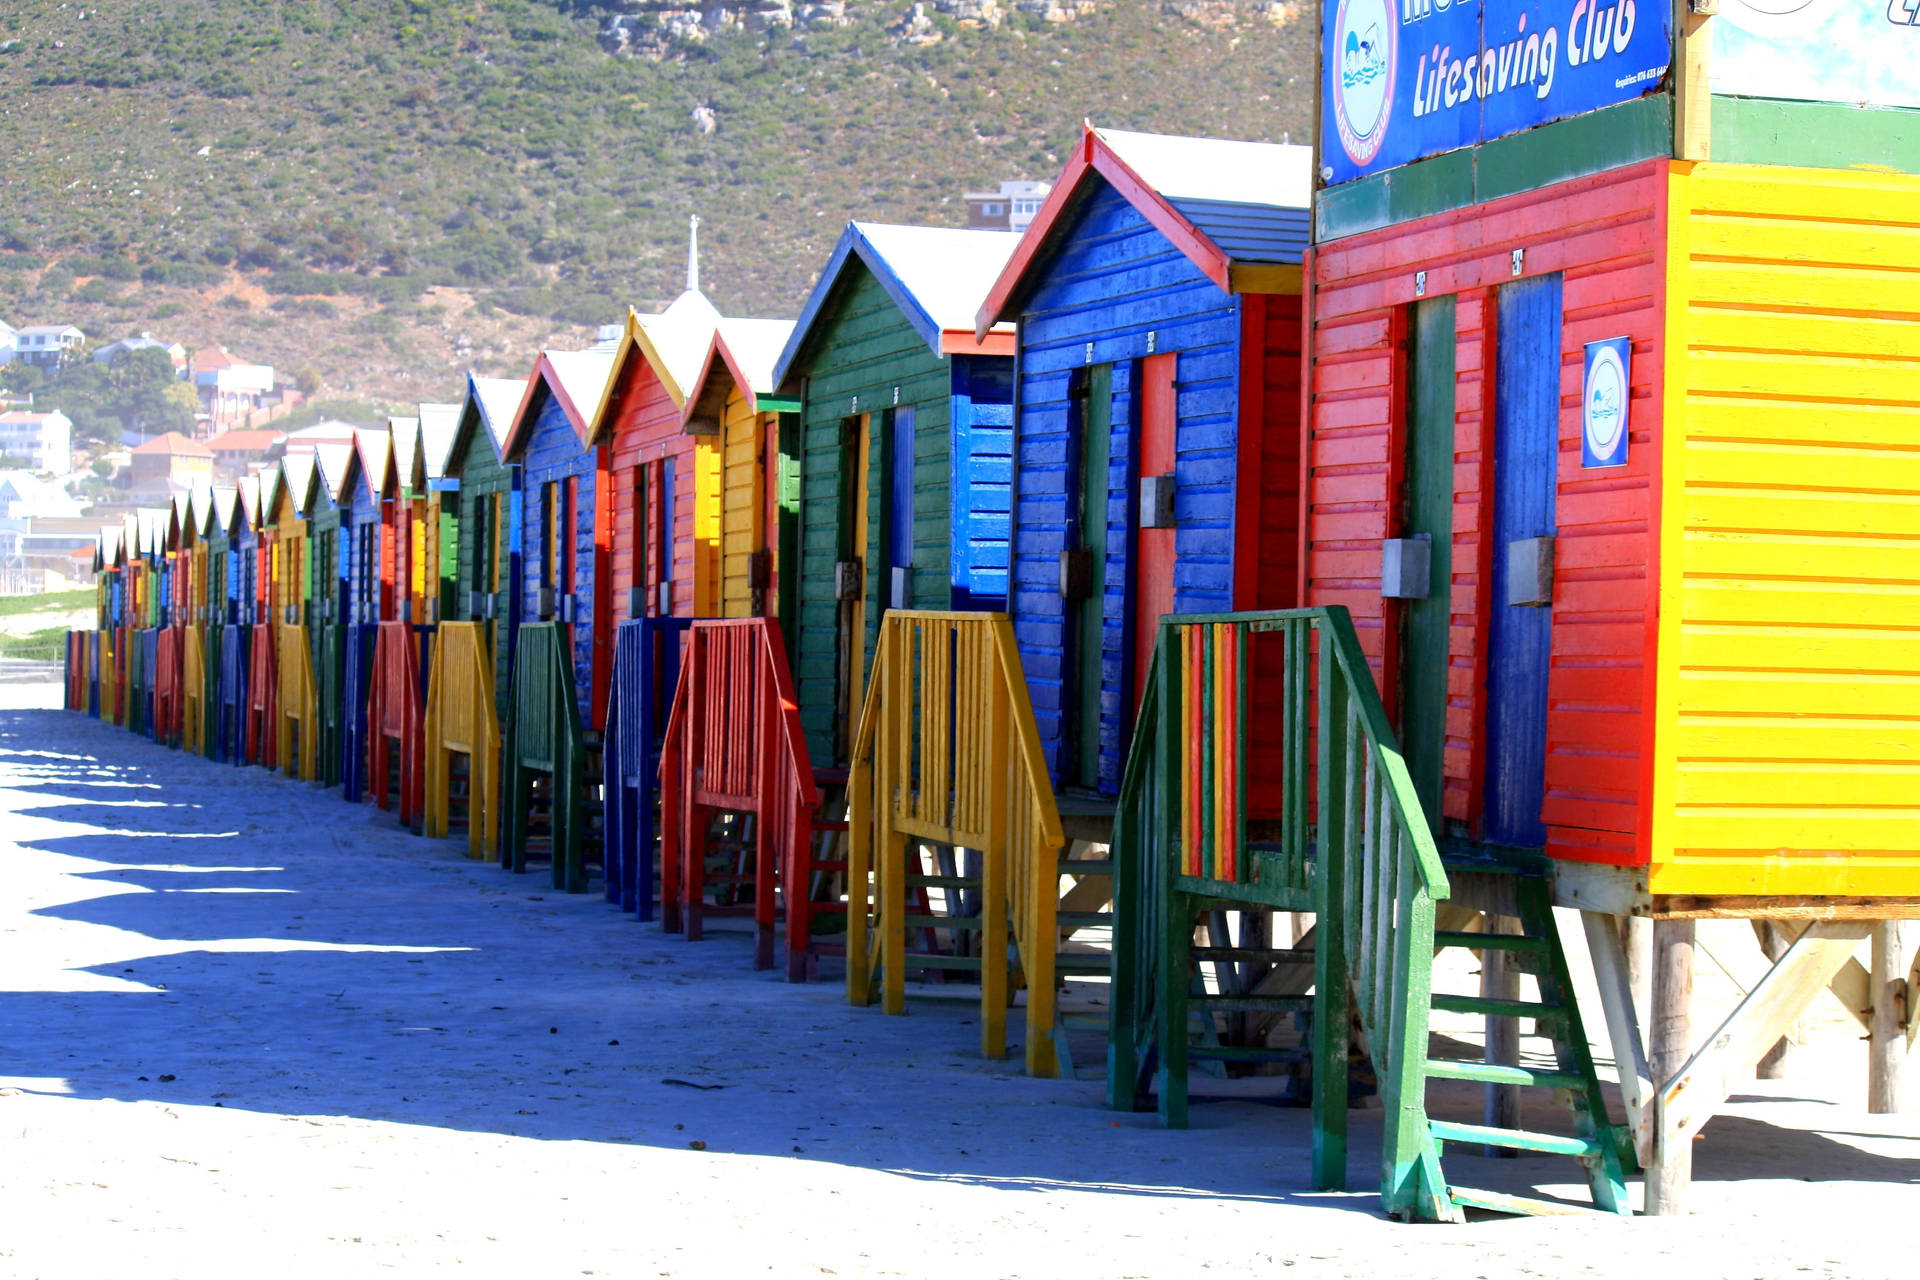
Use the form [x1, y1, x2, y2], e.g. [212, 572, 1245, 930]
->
[503, 349, 614, 892]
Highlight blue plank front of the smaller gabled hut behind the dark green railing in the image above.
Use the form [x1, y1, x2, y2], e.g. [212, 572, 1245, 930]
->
[515, 384, 612, 727]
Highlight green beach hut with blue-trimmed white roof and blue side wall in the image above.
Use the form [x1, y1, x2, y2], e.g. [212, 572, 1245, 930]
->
[774, 223, 1020, 764]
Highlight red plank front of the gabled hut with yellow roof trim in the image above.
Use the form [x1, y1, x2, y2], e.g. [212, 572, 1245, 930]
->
[601, 351, 695, 618]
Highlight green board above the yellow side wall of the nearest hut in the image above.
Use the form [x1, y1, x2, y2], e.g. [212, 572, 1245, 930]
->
[1713, 96, 1920, 173]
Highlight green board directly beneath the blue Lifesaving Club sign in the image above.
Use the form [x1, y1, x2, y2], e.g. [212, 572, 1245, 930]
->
[1313, 94, 1666, 244]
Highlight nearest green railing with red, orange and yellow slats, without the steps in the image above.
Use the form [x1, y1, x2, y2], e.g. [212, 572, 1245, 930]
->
[1108, 606, 1448, 1213]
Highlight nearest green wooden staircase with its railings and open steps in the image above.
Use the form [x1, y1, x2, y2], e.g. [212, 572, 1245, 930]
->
[1108, 608, 1632, 1222]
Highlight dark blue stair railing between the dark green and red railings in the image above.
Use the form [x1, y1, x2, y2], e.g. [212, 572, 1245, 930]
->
[601, 618, 691, 919]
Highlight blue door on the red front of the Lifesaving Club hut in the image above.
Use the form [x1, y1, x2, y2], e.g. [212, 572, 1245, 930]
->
[1482, 274, 1561, 848]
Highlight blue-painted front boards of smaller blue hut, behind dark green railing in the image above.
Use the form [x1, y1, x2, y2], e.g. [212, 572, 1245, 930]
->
[515, 382, 605, 723]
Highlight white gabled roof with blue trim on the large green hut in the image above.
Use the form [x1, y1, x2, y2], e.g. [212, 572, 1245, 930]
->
[776, 223, 1020, 386]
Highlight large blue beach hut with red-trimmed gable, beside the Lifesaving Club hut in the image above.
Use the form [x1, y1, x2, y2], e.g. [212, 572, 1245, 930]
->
[979, 125, 1311, 796]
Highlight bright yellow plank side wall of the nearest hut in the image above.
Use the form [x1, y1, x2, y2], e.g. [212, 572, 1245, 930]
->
[1636, 165, 1920, 896]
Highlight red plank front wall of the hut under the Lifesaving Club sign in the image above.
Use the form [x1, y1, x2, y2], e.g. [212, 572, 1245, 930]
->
[1306, 161, 1667, 864]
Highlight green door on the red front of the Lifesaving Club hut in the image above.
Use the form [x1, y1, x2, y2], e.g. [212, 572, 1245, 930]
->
[1400, 297, 1453, 831]
